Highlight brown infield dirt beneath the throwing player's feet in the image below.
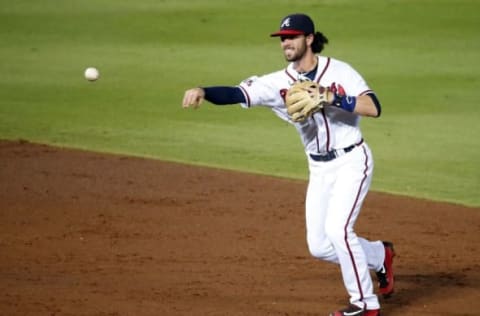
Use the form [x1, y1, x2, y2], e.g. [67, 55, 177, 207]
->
[0, 141, 480, 316]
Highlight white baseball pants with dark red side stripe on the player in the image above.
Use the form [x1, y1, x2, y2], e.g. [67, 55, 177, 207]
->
[305, 142, 385, 309]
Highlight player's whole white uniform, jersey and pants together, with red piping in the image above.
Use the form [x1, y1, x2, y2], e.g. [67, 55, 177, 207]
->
[239, 56, 385, 309]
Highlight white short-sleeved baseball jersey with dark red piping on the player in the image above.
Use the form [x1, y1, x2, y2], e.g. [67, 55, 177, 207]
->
[239, 56, 372, 157]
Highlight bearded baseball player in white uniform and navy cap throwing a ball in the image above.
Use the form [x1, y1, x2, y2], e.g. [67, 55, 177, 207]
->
[183, 14, 395, 316]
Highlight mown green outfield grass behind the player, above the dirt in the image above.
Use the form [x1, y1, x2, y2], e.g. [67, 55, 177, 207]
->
[0, 0, 480, 206]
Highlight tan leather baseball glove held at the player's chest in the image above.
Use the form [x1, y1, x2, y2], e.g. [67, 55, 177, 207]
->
[285, 81, 333, 122]
